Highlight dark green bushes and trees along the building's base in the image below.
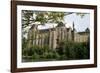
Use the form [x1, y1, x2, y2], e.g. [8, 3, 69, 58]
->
[23, 41, 90, 61]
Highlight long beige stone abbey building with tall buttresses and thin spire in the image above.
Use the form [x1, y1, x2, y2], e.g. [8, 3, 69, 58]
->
[28, 23, 89, 49]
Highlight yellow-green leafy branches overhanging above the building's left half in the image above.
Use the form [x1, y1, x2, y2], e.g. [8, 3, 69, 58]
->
[22, 10, 65, 28]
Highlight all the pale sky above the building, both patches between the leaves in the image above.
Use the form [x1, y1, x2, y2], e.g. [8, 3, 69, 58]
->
[38, 13, 90, 32]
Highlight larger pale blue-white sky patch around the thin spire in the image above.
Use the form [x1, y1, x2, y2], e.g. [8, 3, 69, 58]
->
[64, 13, 90, 32]
